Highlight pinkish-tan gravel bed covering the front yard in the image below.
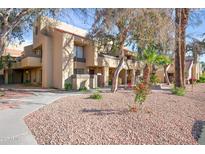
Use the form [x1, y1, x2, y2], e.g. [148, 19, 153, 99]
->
[25, 84, 205, 144]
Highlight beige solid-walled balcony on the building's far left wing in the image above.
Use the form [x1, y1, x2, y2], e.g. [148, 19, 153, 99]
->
[12, 57, 41, 69]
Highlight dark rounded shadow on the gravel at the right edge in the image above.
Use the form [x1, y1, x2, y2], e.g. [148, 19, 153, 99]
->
[192, 120, 205, 141]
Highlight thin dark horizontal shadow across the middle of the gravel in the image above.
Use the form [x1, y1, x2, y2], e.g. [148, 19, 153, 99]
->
[80, 108, 129, 116]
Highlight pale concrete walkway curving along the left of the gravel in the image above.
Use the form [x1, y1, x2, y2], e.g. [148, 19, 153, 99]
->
[0, 92, 79, 145]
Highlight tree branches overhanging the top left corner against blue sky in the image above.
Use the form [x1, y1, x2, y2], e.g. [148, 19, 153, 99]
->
[0, 8, 87, 55]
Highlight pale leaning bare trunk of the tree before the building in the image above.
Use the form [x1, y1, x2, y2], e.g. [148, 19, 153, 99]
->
[111, 57, 125, 93]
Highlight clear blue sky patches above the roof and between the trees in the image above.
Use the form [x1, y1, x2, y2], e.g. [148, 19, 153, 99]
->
[24, 9, 205, 62]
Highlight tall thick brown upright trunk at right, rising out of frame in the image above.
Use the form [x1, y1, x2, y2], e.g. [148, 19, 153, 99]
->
[175, 8, 189, 88]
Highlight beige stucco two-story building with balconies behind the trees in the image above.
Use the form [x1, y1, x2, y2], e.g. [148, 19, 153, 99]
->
[5, 18, 139, 89]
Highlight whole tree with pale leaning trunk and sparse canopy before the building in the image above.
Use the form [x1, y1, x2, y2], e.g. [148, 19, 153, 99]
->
[91, 9, 140, 92]
